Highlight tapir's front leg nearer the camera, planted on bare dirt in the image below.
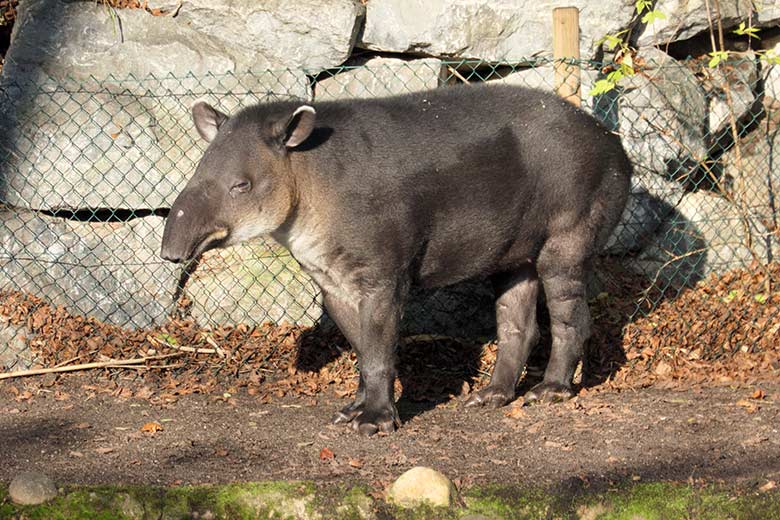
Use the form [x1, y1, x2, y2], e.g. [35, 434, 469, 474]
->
[337, 285, 406, 435]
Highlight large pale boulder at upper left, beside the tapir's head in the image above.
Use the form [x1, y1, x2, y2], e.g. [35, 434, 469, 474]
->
[0, 0, 318, 210]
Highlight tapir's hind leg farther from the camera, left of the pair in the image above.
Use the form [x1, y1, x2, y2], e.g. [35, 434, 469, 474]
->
[466, 264, 539, 408]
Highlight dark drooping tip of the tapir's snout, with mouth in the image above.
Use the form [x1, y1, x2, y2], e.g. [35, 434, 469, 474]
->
[160, 192, 230, 263]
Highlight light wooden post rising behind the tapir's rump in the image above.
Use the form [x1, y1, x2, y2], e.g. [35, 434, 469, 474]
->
[553, 7, 582, 106]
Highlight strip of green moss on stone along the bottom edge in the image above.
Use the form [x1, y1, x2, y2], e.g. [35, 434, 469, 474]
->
[0, 481, 780, 520]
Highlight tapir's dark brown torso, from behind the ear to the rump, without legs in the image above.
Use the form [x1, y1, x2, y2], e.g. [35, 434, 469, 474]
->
[290, 85, 631, 285]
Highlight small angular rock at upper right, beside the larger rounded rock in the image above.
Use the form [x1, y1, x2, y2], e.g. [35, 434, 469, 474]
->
[702, 52, 758, 136]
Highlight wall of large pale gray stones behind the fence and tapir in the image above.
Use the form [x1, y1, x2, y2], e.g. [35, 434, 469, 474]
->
[0, 0, 780, 335]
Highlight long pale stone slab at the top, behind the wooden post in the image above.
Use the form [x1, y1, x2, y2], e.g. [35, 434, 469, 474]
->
[358, 0, 633, 61]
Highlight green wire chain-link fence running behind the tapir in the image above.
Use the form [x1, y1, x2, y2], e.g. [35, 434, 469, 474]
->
[0, 57, 780, 378]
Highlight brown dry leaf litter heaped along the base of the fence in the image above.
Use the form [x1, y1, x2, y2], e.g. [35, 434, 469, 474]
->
[0, 264, 780, 402]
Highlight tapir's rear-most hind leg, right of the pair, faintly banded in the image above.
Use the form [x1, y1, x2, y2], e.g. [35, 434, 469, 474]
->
[525, 226, 593, 403]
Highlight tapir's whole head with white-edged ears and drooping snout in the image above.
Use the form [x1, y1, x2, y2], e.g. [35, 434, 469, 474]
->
[161, 102, 315, 262]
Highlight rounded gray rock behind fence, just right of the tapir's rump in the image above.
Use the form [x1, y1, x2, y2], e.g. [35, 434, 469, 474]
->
[613, 49, 707, 181]
